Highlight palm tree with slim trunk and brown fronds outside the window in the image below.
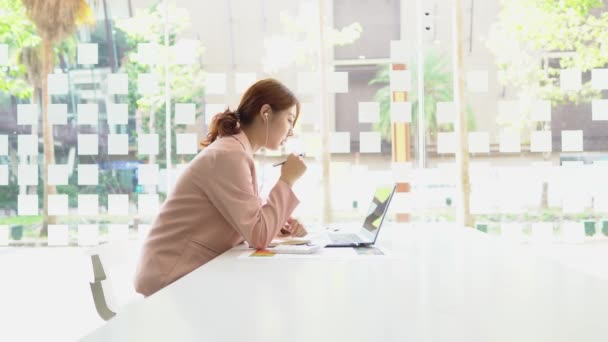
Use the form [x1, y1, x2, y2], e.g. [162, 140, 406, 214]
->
[22, 0, 94, 236]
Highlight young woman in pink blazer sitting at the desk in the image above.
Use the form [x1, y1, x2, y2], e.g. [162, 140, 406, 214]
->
[135, 79, 306, 296]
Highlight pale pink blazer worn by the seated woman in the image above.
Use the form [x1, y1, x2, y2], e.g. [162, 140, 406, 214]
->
[135, 133, 299, 296]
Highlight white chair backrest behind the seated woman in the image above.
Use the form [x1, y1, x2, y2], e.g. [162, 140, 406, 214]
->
[87, 241, 143, 321]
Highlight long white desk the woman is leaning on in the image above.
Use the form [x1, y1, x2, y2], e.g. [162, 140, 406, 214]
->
[84, 226, 608, 342]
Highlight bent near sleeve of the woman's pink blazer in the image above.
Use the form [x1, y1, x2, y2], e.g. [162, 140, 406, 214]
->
[203, 151, 300, 249]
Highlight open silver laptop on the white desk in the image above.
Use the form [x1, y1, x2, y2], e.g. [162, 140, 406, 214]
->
[325, 185, 397, 247]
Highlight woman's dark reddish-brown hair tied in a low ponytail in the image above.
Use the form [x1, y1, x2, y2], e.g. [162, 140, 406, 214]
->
[201, 78, 300, 147]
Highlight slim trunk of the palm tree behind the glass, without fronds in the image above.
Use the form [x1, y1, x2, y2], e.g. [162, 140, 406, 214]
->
[40, 39, 57, 237]
